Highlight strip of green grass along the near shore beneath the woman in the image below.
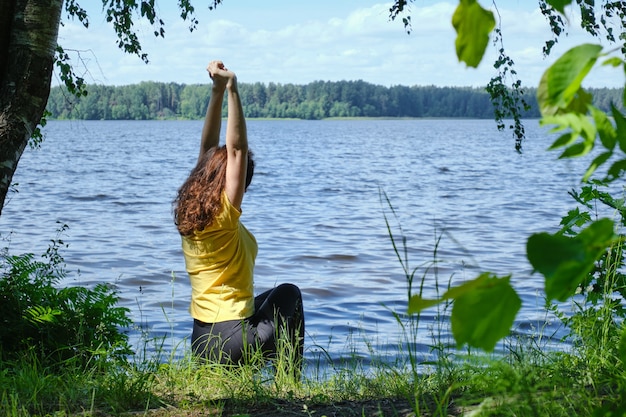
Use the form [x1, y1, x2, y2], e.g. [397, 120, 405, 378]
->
[0, 286, 626, 417]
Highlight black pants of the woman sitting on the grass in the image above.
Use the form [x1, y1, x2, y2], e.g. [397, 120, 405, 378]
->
[191, 284, 304, 364]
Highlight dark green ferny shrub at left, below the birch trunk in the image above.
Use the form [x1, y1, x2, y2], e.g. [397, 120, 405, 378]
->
[0, 226, 131, 364]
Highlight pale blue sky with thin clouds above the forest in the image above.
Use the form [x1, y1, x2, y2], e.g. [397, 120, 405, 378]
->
[53, 0, 624, 87]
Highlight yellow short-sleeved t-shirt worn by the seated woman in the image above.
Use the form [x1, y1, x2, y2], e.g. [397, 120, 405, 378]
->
[182, 192, 258, 323]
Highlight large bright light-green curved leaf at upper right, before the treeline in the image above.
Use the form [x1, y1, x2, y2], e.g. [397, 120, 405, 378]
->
[537, 44, 602, 116]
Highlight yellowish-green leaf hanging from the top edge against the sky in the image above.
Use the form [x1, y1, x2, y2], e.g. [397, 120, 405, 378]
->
[452, 0, 496, 68]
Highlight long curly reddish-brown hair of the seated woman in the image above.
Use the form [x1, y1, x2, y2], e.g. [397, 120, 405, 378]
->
[174, 146, 254, 236]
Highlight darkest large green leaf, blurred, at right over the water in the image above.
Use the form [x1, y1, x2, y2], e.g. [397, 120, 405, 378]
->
[526, 219, 615, 301]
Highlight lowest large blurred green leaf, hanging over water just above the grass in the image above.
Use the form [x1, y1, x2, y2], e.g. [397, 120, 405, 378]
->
[450, 273, 522, 352]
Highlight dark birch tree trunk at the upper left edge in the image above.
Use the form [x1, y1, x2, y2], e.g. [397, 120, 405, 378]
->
[0, 0, 63, 214]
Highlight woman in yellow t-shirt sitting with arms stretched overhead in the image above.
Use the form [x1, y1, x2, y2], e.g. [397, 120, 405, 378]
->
[174, 61, 304, 366]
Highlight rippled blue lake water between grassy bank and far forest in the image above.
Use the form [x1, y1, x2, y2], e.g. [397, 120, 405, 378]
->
[0, 120, 583, 368]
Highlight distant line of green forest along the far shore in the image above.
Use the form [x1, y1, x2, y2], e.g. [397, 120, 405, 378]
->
[47, 81, 623, 120]
